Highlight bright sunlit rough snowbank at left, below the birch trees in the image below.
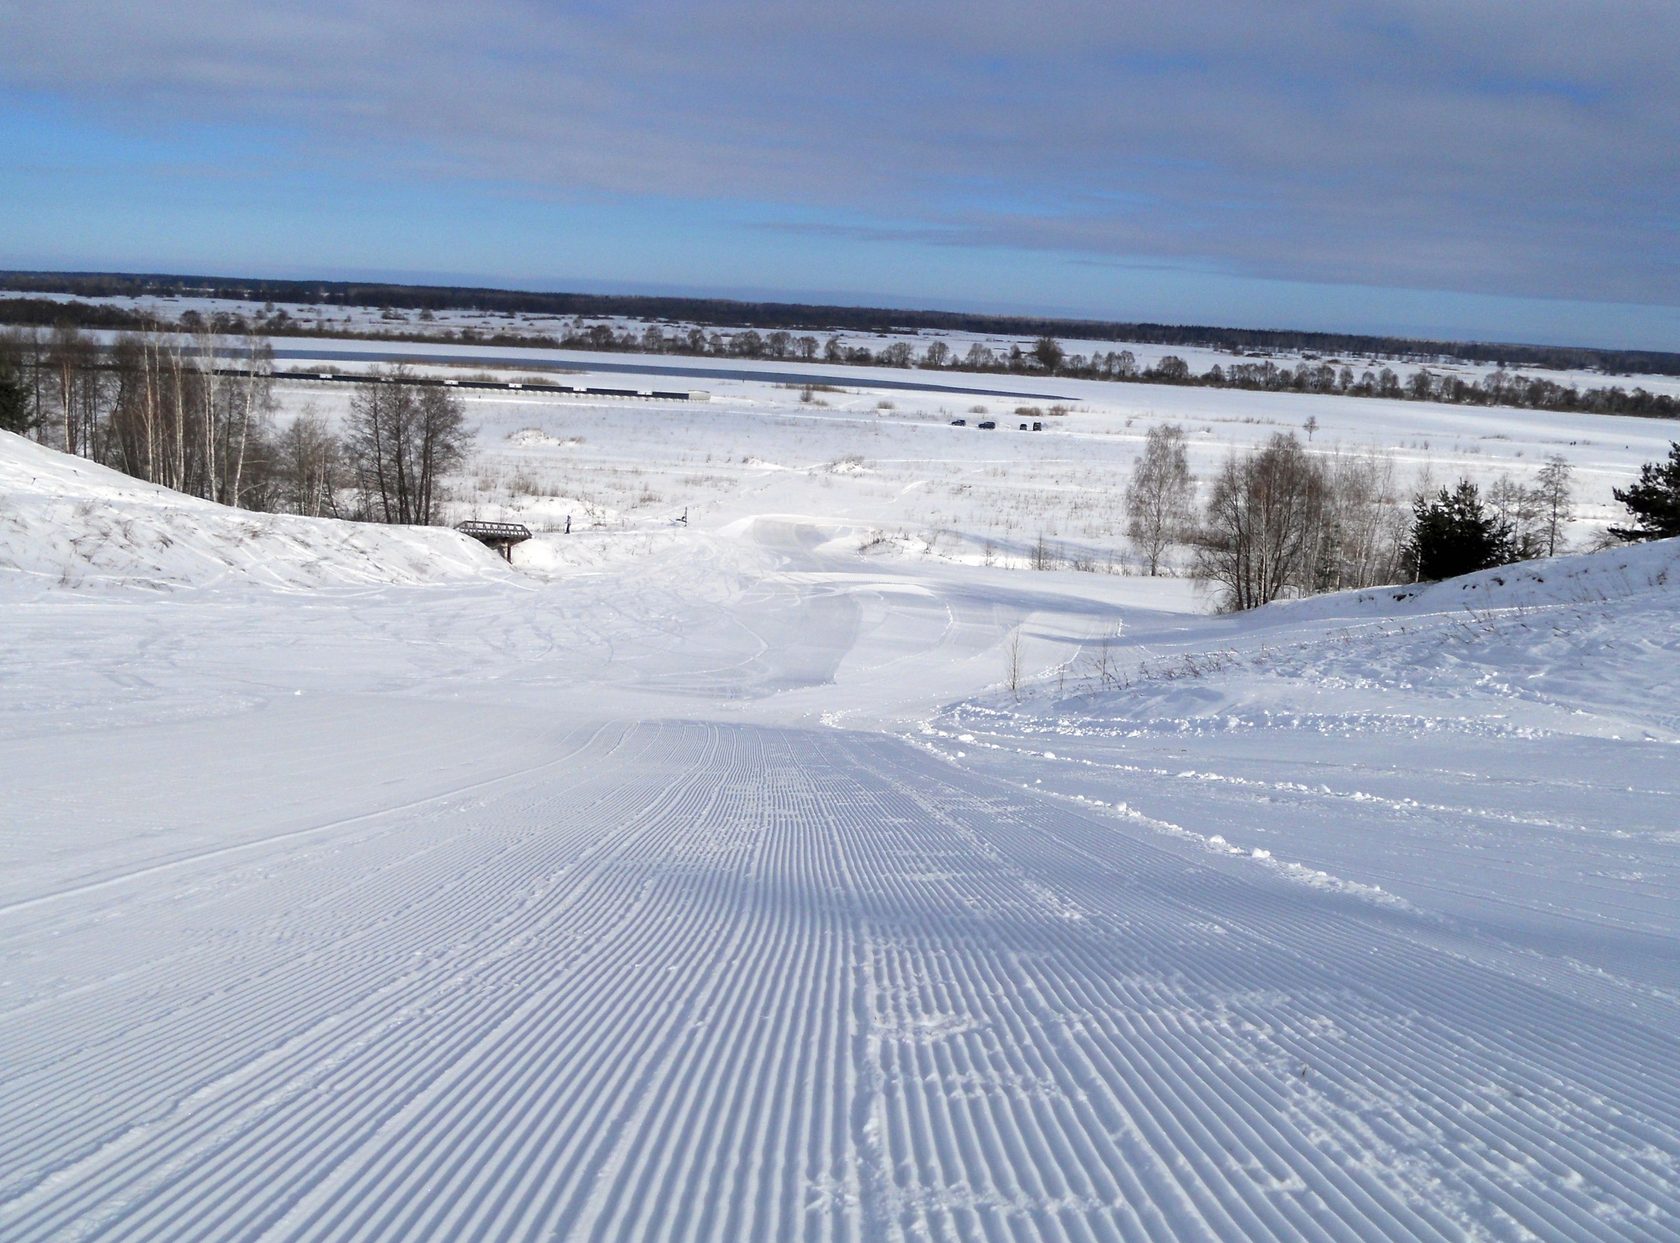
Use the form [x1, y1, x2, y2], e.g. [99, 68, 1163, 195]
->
[0, 432, 509, 590]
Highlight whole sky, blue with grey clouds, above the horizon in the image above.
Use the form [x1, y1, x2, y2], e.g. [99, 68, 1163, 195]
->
[0, 0, 1680, 349]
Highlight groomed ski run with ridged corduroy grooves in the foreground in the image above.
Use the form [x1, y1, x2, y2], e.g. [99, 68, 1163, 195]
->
[0, 722, 1680, 1243]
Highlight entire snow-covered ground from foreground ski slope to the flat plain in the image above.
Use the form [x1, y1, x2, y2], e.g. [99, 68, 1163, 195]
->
[0, 364, 1680, 1240]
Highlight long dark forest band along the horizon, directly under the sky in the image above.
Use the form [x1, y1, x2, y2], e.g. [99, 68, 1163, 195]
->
[0, 272, 1680, 376]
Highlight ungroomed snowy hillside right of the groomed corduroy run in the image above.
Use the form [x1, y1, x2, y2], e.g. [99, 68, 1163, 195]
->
[924, 539, 1680, 987]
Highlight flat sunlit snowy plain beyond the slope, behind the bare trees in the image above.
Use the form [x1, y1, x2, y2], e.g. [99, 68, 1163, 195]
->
[243, 339, 1677, 568]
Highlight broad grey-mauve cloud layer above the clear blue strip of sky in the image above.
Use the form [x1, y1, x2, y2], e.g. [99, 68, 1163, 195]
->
[0, 0, 1680, 306]
